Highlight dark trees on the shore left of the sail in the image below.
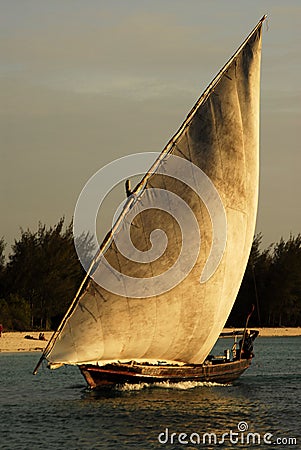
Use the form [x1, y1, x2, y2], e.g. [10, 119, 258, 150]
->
[0, 218, 93, 331]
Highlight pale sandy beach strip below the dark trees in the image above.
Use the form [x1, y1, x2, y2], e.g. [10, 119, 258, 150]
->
[0, 327, 301, 353]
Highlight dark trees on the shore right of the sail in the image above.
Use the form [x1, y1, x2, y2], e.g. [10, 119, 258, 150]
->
[227, 234, 301, 327]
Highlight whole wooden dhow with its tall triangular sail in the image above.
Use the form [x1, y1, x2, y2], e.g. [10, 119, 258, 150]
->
[34, 16, 265, 388]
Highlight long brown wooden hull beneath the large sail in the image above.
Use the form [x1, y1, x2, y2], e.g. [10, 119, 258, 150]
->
[79, 359, 251, 389]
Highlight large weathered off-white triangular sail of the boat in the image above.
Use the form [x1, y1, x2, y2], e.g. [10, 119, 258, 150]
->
[44, 20, 262, 365]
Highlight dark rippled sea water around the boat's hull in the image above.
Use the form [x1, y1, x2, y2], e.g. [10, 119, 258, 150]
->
[0, 337, 301, 450]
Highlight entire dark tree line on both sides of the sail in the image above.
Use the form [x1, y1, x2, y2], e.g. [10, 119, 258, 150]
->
[0, 218, 301, 331]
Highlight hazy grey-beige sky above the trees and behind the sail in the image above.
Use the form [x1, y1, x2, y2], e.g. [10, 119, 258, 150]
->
[0, 0, 301, 252]
